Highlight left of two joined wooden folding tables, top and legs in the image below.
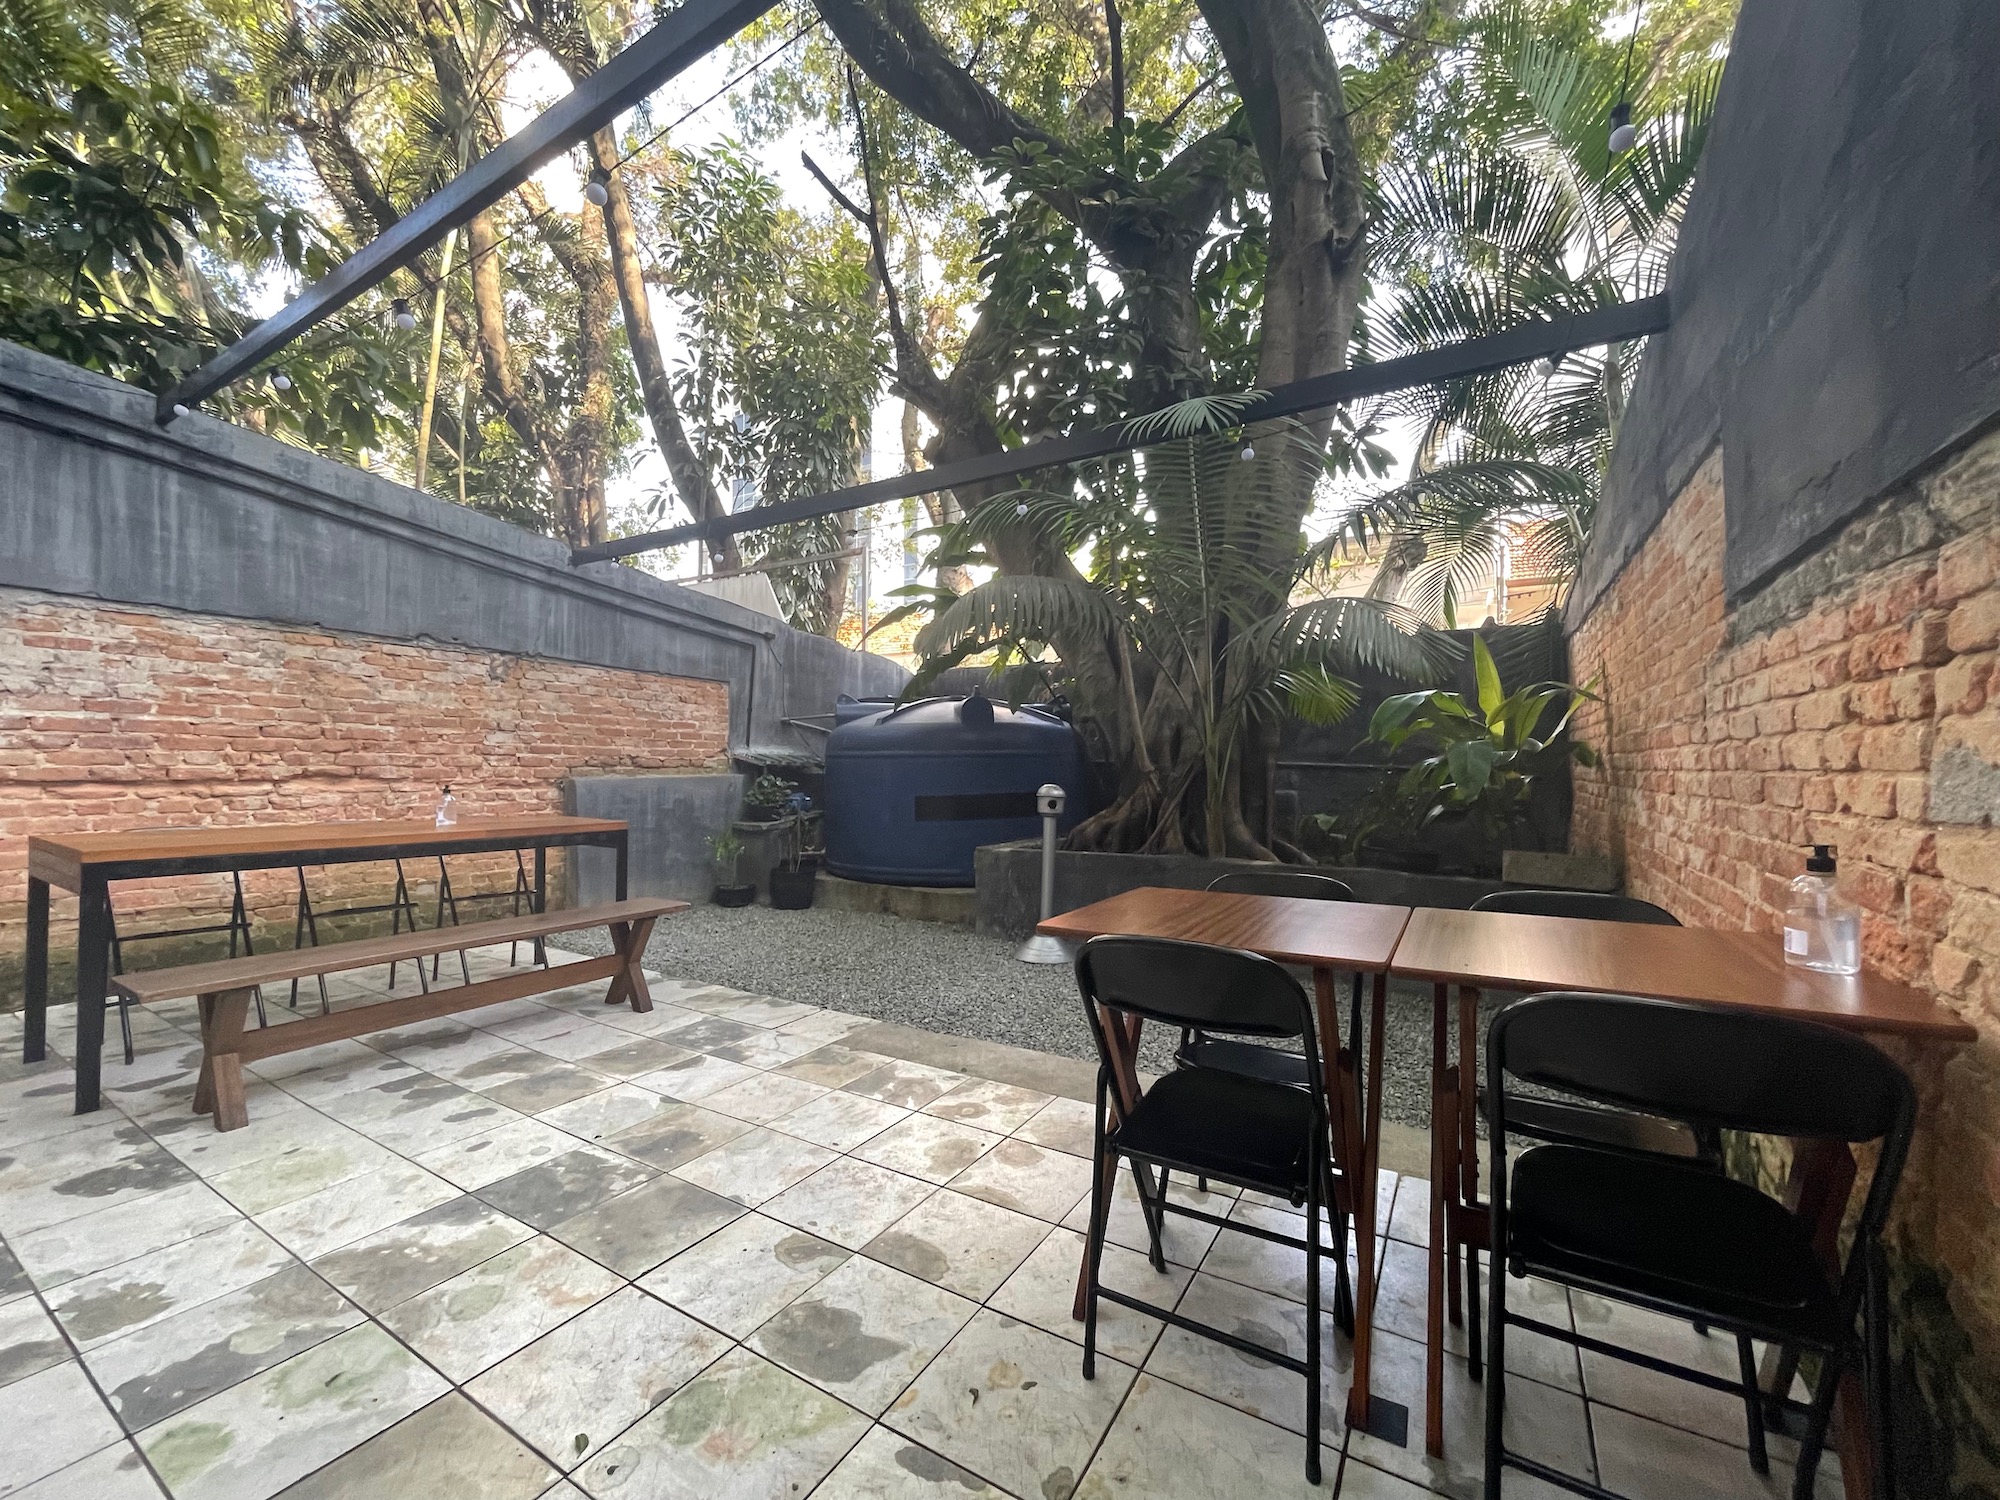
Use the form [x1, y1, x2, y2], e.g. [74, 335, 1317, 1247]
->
[1036, 886, 1410, 1444]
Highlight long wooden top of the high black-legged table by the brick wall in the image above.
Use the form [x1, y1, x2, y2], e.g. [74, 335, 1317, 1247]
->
[28, 812, 626, 884]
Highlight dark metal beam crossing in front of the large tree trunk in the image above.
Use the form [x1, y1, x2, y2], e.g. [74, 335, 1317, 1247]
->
[570, 294, 1670, 566]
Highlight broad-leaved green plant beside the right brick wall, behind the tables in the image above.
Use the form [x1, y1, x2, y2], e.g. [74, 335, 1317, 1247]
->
[1314, 636, 1598, 860]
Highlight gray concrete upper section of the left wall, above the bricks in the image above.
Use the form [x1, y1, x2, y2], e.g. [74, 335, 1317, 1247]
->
[0, 344, 908, 750]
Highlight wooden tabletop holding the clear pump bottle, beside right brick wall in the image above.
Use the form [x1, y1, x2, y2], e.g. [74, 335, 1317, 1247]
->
[1390, 906, 1974, 1042]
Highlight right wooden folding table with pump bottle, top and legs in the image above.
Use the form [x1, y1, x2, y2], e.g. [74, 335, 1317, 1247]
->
[1390, 908, 1974, 1472]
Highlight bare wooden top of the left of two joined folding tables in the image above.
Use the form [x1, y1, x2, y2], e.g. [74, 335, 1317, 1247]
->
[1036, 886, 1410, 970]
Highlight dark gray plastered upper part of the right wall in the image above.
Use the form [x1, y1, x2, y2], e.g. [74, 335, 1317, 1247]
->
[1570, 0, 2000, 620]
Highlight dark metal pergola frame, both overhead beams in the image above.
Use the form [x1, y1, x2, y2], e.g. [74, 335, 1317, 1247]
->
[154, 0, 1672, 566]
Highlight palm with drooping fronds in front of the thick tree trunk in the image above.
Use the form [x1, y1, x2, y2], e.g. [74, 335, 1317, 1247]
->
[884, 398, 1456, 858]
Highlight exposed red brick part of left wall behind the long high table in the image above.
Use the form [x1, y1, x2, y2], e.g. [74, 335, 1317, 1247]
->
[0, 590, 730, 964]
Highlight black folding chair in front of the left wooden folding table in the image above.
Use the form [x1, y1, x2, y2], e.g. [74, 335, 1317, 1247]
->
[1076, 938, 1354, 1484]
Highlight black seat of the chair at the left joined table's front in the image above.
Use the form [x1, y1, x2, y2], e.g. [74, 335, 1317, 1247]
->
[1110, 1068, 1312, 1198]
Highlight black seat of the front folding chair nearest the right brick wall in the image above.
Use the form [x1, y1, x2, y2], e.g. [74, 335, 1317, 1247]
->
[1508, 1146, 1842, 1344]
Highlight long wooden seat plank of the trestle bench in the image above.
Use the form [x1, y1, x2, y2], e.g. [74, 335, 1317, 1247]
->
[112, 896, 688, 1004]
